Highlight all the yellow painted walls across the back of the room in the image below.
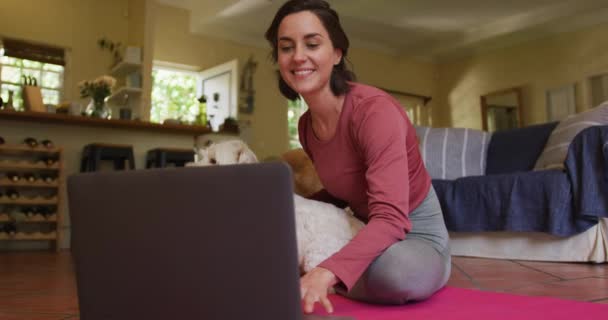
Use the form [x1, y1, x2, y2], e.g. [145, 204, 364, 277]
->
[0, 0, 608, 134]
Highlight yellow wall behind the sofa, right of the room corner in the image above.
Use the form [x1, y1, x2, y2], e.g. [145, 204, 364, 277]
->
[434, 24, 608, 129]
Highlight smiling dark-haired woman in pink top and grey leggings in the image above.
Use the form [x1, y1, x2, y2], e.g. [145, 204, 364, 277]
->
[266, 0, 450, 313]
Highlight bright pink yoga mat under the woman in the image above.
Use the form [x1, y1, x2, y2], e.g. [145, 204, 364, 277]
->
[315, 287, 608, 320]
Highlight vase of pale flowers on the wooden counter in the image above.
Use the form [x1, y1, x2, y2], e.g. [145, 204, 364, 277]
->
[78, 76, 116, 119]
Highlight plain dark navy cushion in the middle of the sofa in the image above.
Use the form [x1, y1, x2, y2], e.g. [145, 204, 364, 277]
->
[486, 122, 557, 174]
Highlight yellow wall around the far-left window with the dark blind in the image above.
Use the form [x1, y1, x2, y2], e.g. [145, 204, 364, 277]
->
[0, 0, 135, 100]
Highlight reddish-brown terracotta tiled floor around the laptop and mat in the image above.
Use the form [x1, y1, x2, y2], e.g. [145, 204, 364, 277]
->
[0, 251, 608, 320]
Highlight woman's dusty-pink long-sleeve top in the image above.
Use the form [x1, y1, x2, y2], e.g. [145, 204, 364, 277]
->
[298, 83, 431, 290]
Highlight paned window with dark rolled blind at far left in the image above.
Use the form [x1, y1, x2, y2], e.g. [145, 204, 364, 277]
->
[0, 39, 65, 110]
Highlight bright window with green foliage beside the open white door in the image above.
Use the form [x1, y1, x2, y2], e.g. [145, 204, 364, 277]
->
[150, 69, 199, 123]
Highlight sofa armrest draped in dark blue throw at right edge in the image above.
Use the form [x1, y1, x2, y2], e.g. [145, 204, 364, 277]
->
[564, 126, 608, 217]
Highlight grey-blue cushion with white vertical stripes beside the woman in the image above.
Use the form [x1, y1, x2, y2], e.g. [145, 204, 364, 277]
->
[416, 127, 491, 180]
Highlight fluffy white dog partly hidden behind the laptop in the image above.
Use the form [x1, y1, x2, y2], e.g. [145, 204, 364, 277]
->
[186, 140, 363, 273]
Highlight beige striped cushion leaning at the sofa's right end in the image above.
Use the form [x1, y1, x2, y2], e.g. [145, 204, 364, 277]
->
[534, 101, 608, 170]
